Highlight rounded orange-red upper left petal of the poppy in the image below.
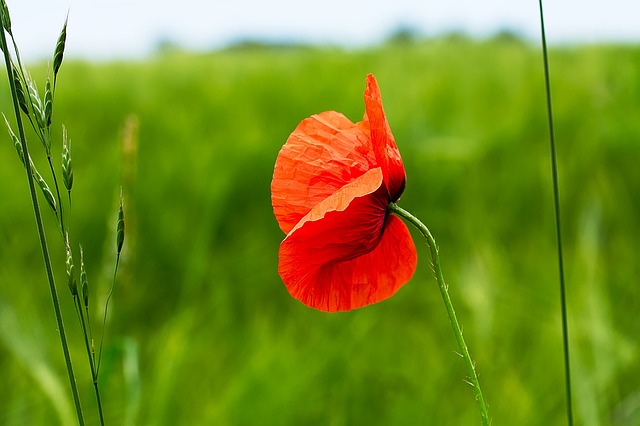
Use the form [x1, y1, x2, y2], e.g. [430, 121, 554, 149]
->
[271, 111, 375, 233]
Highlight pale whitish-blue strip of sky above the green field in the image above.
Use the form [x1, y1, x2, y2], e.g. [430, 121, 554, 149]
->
[6, 0, 640, 60]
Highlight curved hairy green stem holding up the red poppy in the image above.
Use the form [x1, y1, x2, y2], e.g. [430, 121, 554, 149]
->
[389, 203, 491, 426]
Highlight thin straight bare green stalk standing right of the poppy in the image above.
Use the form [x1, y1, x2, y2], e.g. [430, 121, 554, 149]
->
[539, 0, 573, 426]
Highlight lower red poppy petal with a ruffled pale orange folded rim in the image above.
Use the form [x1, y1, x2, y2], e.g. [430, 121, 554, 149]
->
[278, 168, 417, 312]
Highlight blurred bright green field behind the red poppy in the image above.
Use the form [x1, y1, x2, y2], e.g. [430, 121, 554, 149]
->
[0, 37, 640, 426]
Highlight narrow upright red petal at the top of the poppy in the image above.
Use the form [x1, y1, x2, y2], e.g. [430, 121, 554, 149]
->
[359, 74, 407, 202]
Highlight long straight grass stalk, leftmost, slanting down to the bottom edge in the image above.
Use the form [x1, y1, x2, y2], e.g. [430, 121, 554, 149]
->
[0, 19, 84, 426]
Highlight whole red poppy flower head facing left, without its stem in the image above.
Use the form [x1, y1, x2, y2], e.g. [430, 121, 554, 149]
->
[271, 74, 417, 312]
